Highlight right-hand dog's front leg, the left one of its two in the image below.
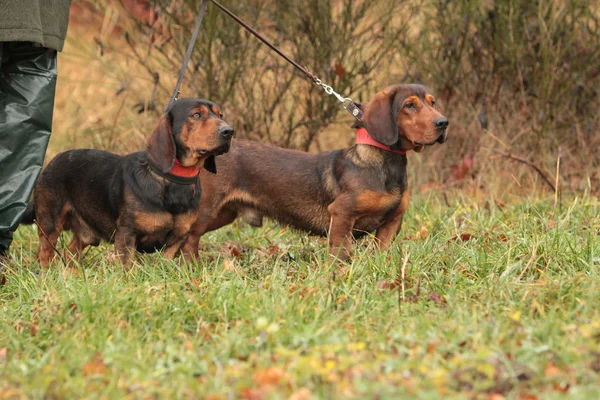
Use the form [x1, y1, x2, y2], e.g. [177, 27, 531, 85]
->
[327, 199, 356, 261]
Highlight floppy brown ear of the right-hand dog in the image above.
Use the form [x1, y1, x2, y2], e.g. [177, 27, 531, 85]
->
[362, 91, 398, 146]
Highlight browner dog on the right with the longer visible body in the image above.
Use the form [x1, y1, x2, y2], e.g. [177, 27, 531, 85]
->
[182, 85, 448, 258]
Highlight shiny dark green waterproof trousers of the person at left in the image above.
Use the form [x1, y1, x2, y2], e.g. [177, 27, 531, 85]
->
[0, 42, 56, 255]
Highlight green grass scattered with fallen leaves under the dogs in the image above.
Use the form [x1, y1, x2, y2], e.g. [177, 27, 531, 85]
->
[0, 196, 600, 400]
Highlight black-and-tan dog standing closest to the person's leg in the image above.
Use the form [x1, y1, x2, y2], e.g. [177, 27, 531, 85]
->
[21, 99, 233, 266]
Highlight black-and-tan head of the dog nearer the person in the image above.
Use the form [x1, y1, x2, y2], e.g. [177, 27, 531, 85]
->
[146, 99, 233, 173]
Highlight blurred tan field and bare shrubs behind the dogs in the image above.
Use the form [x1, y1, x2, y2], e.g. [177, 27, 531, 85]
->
[52, 0, 600, 198]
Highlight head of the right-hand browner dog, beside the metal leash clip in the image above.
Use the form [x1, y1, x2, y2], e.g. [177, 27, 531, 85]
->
[362, 84, 448, 152]
